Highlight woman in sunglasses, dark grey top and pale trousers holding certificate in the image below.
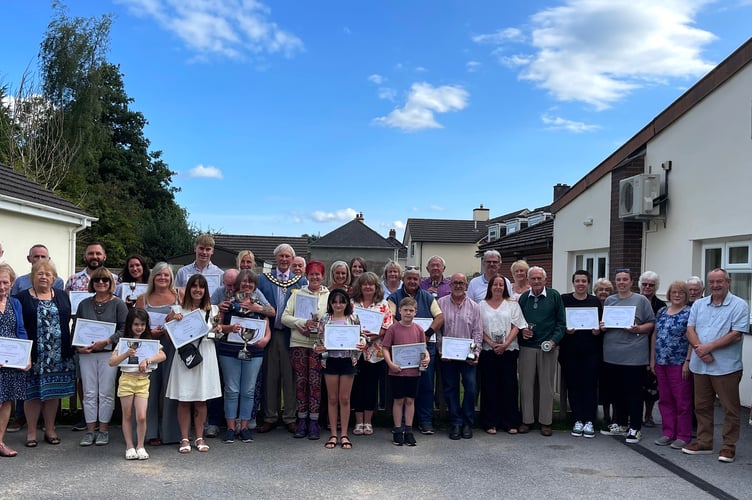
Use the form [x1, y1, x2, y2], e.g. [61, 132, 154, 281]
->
[76, 267, 128, 446]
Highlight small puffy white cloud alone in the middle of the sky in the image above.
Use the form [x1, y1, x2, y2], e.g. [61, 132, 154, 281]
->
[374, 82, 470, 131]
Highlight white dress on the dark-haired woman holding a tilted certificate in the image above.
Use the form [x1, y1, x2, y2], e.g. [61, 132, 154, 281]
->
[165, 306, 222, 401]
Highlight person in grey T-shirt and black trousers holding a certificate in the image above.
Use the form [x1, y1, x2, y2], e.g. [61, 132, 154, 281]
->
[601, 269, 655, 444]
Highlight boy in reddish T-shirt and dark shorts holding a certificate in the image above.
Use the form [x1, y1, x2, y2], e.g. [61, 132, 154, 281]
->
[382, 297, 431, 446]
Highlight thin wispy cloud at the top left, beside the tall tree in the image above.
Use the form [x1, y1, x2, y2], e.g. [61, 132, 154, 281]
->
[116, 0, 303, 60]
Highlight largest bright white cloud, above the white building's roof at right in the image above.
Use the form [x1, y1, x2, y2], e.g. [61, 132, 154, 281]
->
[473, 0, 716, 110]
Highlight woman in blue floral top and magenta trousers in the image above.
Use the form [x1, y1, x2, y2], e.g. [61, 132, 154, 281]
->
[650, 281, 693, 450]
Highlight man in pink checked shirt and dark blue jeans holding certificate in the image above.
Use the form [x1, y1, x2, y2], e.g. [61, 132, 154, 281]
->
[438, 273, 483, 440]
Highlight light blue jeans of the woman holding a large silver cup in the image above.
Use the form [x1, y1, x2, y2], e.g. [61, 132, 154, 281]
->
[219, 356, 264, 420]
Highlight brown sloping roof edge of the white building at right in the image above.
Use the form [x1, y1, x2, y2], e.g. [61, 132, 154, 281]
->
[551, 38, 752, 213]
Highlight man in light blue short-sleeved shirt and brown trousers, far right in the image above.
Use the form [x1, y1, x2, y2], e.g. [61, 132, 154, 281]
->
[682, 269, 749, 463]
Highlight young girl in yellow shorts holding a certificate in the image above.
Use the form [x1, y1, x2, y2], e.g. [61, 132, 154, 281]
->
[109, 307, 167, 460]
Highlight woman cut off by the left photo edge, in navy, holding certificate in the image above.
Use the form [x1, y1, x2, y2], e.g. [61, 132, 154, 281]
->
[0, 264, 31, 457]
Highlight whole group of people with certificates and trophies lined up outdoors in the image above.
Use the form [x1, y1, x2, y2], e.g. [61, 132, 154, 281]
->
[0, 235, 749, 462]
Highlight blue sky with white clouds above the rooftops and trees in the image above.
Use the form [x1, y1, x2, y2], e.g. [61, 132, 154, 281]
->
[0, 0, 752, 239]
